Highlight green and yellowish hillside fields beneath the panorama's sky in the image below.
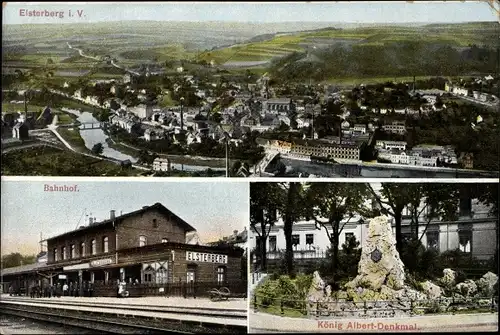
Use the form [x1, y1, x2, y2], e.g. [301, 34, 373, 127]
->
[2, 21, 500, 80]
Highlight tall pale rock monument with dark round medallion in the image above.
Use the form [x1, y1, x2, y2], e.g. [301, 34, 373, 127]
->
[345, 216, 405, 291]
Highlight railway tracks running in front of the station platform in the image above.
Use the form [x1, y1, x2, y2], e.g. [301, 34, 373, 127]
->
[0, 299, 247, 334]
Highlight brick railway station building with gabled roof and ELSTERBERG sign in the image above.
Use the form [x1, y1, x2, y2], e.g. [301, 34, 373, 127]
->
[2, 203, 246, 296]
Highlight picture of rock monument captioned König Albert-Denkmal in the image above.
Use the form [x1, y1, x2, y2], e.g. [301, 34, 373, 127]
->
[248, 182, 499, 333]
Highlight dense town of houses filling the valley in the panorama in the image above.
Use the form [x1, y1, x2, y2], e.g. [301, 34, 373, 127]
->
[2, 52, 499, 176]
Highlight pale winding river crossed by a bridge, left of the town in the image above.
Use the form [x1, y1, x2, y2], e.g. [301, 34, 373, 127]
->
[61, 108, 225, 172]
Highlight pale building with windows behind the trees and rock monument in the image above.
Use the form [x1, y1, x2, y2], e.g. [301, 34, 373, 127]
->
[252, 192, 498, 269]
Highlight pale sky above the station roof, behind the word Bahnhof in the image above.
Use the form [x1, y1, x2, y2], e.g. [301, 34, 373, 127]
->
[1, 179, 249, 255]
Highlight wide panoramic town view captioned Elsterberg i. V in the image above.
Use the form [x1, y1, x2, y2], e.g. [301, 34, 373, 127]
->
[1, 1, 500, 178]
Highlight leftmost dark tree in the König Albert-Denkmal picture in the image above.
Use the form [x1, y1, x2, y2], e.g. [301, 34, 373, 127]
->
[250, 183, 283, 271]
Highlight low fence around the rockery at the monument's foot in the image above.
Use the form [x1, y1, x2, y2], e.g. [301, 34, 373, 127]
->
[251, 294, 498, 318]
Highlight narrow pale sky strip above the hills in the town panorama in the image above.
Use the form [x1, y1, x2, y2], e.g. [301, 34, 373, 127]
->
[2, 0, 499, 24]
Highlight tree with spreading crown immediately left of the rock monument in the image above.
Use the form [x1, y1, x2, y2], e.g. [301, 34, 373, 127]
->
[306, 183, 369, 278]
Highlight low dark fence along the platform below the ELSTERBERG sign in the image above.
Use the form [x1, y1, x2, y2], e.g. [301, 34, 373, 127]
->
[93, 280, 248, 298]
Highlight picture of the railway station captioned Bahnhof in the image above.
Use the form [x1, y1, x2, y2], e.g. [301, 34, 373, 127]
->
[0, 178, 249, 334]
